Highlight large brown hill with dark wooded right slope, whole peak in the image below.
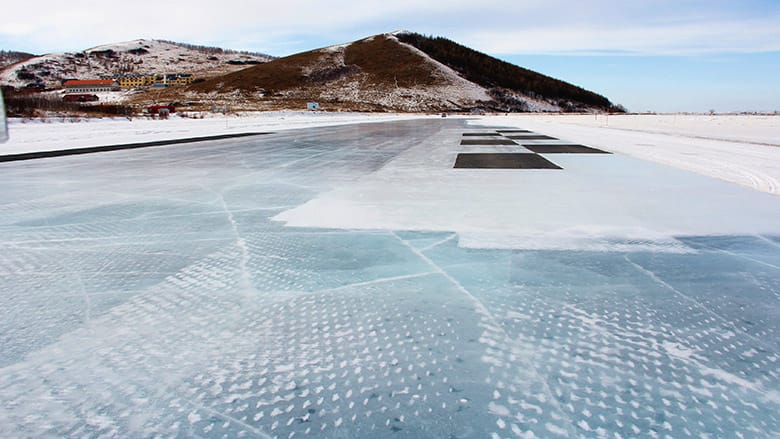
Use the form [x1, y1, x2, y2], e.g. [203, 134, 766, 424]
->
[186, 32, 614, 111]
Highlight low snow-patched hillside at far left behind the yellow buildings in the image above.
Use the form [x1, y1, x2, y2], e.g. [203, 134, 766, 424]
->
[0, 39, 272, 87]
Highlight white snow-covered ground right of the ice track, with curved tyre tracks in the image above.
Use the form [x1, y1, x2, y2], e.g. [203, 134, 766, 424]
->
[475, 115, 780, 194]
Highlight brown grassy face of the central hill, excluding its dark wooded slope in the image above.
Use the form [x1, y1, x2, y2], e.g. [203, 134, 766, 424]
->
[189, 35, 490, 111]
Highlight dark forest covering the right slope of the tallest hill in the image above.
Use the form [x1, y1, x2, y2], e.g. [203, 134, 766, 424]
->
[398, 33, 615, 111]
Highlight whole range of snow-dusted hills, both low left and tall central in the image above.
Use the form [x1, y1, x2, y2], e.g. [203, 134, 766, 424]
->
[0, 31, 623, 112]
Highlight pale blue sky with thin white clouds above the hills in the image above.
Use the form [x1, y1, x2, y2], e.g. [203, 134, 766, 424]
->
[0, 0, 780, 112]
